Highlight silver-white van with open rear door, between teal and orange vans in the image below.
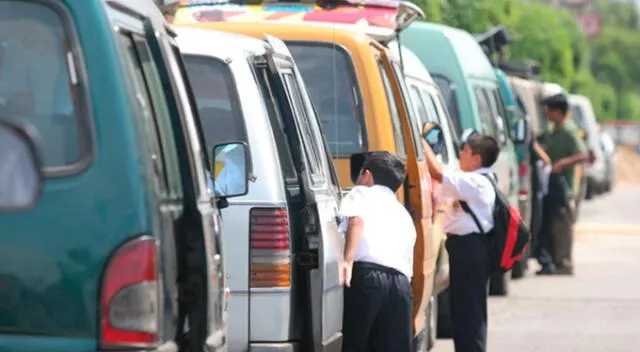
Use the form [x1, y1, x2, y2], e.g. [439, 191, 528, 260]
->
[174, 26, 344, 351]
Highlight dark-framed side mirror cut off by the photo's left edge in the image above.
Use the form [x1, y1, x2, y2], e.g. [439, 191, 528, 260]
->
[0, 121, 44, 211]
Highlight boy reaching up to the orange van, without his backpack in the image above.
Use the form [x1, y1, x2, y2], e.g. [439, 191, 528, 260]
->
[423, 134, 500, 352]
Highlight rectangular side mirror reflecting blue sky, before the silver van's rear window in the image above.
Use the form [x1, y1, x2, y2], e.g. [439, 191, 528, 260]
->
[211, 142, 249, 198]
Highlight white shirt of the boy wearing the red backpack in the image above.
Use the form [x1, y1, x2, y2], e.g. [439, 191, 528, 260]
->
[442, 168, 496, 235]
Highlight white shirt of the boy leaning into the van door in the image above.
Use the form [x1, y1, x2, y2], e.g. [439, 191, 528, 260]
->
[340, 185, 416, 279]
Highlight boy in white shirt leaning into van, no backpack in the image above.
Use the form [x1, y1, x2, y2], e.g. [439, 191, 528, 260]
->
[340, 152, 416, 352]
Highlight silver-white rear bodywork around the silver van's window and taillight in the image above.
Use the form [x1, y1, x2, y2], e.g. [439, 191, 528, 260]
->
[174, 26, 320, 351]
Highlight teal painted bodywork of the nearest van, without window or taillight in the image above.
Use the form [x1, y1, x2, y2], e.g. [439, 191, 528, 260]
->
[0, 0, 211, 351]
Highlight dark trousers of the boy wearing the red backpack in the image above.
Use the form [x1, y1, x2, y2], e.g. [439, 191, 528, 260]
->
[446, 233, 491, 352]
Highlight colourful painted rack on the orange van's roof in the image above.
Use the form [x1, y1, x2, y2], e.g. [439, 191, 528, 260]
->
[172, 0, 424, 42]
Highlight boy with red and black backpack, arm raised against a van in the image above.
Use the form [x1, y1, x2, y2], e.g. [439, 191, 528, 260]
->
[423, 131, 529, 352]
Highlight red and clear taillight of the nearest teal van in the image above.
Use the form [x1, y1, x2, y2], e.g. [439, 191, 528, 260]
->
[100, 237, 160, 349]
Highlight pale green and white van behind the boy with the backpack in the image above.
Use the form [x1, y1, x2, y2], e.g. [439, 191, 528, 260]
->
[401, 22, 519, 295]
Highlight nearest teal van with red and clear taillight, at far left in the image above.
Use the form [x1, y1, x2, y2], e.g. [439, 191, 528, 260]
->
[0, 0, 239, 351]
